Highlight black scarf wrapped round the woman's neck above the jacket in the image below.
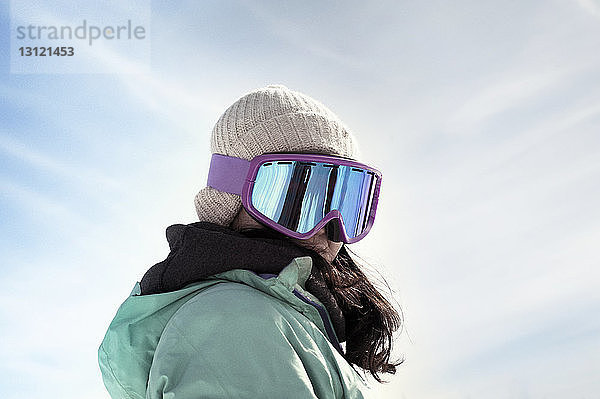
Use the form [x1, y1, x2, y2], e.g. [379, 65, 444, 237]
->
[140, 222, 345, 342]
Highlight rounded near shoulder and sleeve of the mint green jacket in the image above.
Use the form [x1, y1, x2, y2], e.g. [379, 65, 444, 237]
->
[148, 282, 344, 398]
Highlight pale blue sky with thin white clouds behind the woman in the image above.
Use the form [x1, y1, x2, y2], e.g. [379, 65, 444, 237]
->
[0, 0, 600, 399]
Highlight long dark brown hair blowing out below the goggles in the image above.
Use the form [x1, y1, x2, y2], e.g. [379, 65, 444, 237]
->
[240, 228, 404, 382]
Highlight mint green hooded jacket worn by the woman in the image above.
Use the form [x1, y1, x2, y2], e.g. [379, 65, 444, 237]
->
[98, 256, 367, 399]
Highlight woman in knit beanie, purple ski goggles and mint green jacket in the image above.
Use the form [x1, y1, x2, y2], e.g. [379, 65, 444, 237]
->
[99, 85, 400, 399]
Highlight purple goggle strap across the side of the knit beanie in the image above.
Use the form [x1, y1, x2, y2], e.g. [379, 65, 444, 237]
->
[206, 154, 250, 196]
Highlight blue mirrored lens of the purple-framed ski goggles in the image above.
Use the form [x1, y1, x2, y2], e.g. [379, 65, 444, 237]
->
[251, 161, 376, 238]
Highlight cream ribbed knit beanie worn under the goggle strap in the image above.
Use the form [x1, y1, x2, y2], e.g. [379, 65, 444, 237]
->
[194, 85, 359, 226]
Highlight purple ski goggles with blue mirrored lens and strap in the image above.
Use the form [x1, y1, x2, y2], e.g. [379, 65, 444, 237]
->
[207, 153, 381, 244]
